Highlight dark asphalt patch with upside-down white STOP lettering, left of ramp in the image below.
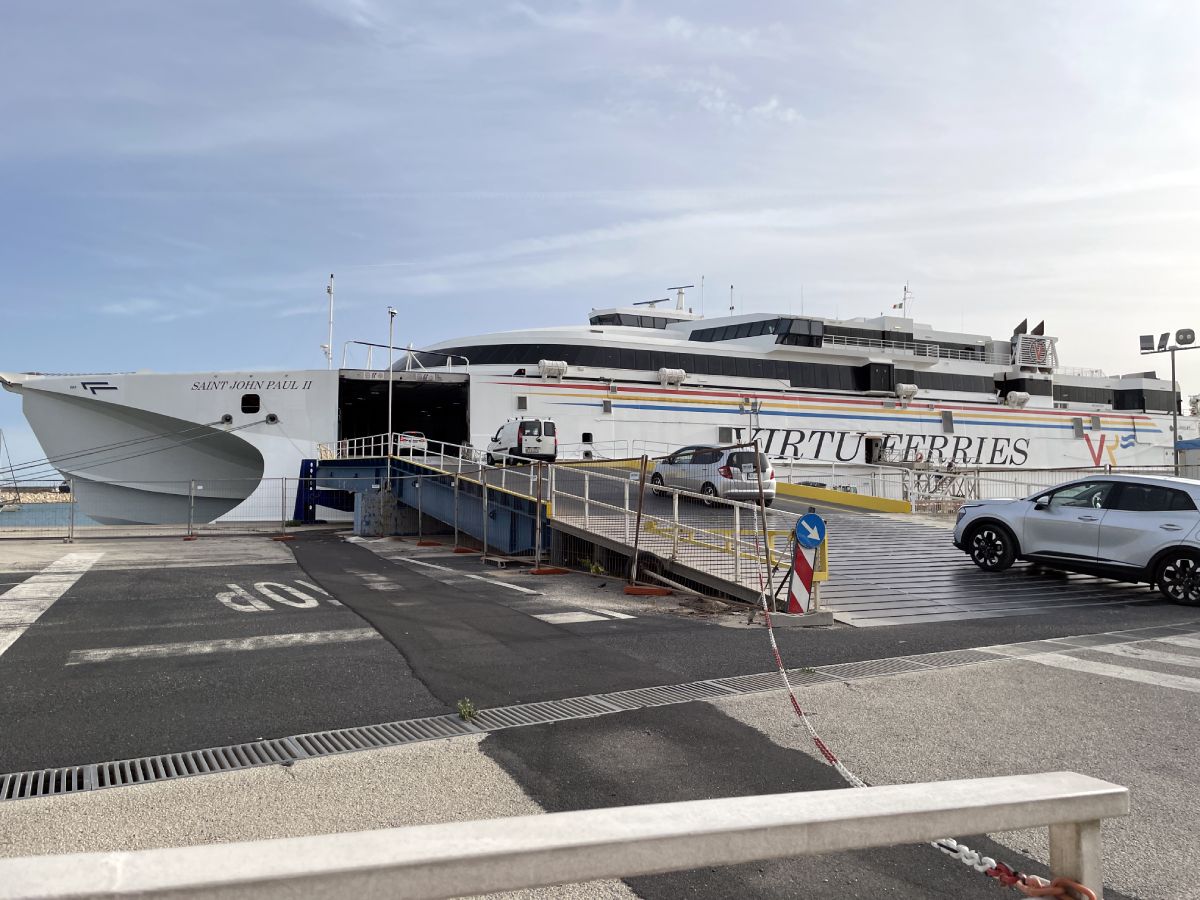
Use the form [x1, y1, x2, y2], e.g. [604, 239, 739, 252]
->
[0, 539, 445, 772]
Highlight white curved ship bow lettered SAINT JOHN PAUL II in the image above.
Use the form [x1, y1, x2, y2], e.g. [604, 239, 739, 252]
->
[4, 370, 337, 524]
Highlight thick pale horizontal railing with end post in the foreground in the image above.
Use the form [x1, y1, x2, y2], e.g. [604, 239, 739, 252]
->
[0, 772, 1129, 900]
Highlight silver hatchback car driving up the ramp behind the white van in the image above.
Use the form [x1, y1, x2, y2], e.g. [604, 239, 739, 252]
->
[650, 446, 775, 506]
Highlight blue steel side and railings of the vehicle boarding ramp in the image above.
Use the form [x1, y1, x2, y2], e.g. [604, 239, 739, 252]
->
[318, 434, 828, 601]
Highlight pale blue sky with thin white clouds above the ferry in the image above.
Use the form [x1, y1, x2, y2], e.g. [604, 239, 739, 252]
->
[0, 0, 1200, 461]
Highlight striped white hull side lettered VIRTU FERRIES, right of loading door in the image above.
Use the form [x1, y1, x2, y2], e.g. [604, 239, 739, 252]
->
[460, 373, 1180, 469]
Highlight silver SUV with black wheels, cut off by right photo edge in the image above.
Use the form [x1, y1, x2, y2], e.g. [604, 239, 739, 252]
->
[954, 475, 1200, 606]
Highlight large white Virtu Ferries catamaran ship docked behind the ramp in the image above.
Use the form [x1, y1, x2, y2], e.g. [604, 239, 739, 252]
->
[0, 289, 1200, 522]
